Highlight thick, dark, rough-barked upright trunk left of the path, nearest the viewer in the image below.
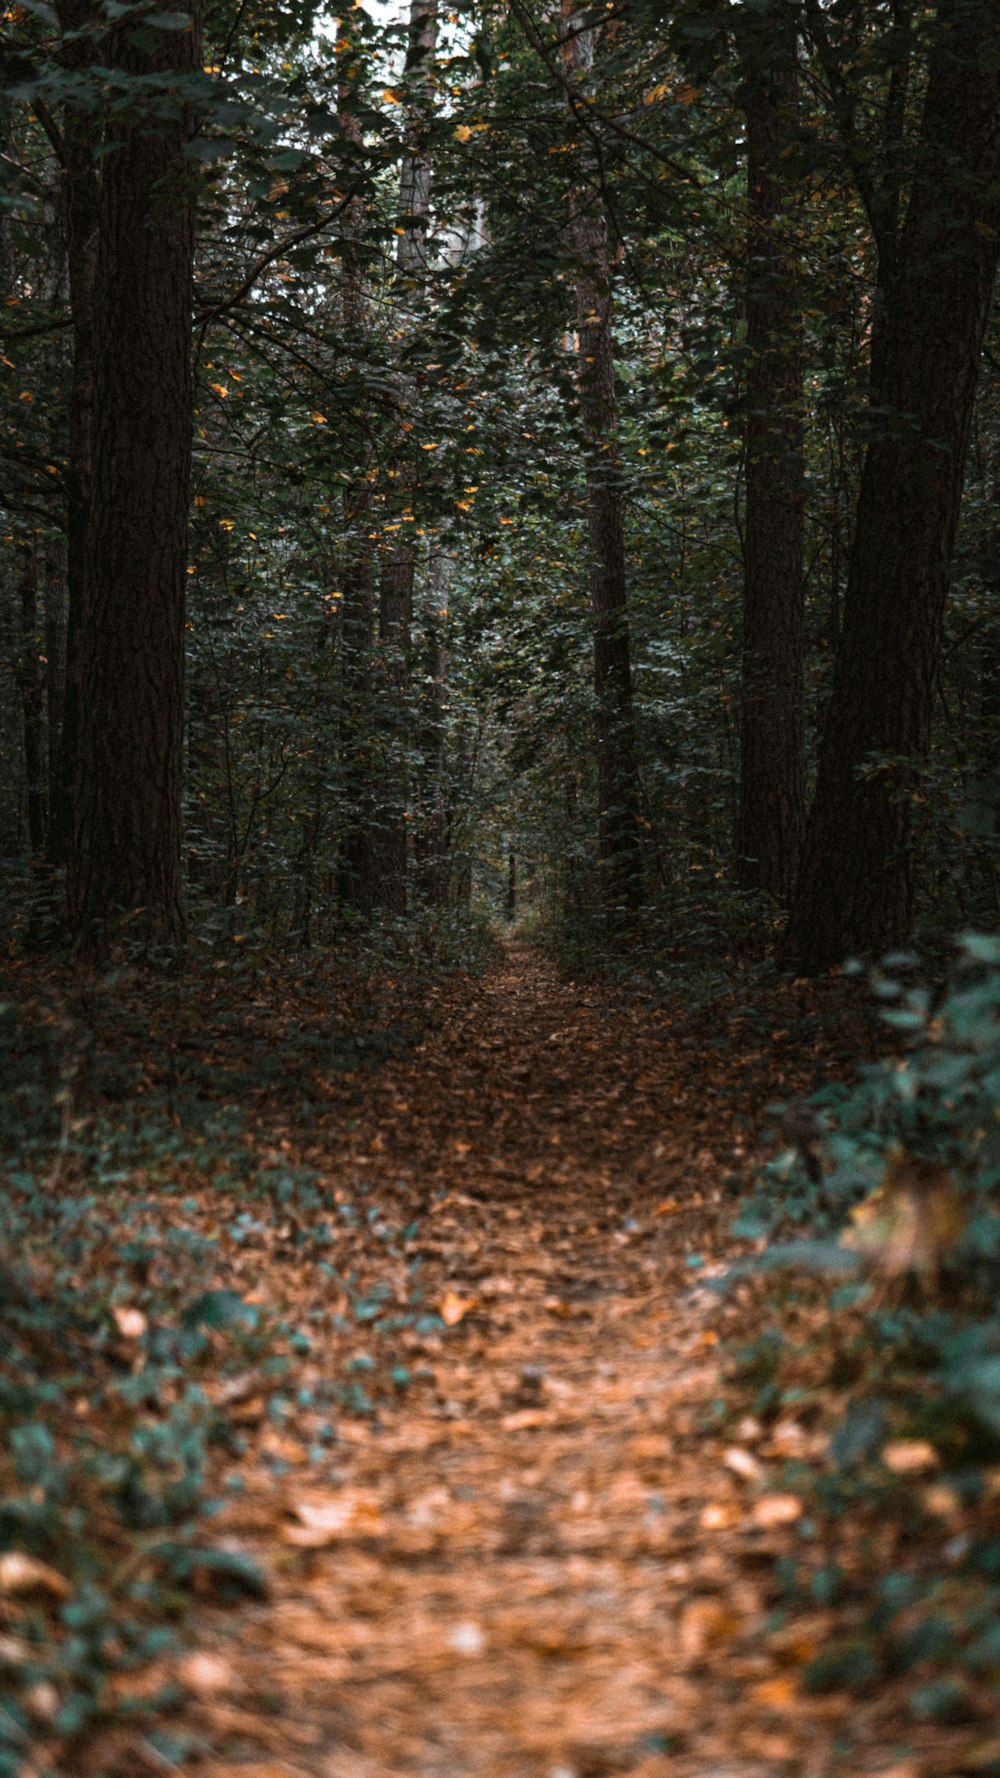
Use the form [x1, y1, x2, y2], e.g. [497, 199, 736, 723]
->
[68, 0, 201, 942]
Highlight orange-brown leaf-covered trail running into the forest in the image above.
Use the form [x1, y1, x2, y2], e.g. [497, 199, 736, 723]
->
[167, 946, 854, 1778]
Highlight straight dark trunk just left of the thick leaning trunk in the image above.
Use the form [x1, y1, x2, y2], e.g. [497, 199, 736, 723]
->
[735, 0, 806, 901]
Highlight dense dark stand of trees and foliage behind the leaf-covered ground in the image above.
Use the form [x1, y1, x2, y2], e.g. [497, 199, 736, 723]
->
[0, 0, 1000, 969]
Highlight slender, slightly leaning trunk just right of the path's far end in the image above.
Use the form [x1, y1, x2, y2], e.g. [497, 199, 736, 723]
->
[562, 0, 642, 919]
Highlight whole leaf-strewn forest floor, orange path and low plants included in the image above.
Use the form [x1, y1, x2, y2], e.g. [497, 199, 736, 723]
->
[0, 944, 996, 1778]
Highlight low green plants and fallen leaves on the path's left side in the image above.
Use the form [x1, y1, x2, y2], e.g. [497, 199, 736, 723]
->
[0, 965, 439, 1774]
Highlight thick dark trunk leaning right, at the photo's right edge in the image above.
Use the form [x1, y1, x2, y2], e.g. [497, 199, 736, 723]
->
[785, 0, 1000, 971]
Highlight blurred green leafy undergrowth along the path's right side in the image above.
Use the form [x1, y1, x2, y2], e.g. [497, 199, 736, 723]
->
[715, 937, 1000, 1773]
